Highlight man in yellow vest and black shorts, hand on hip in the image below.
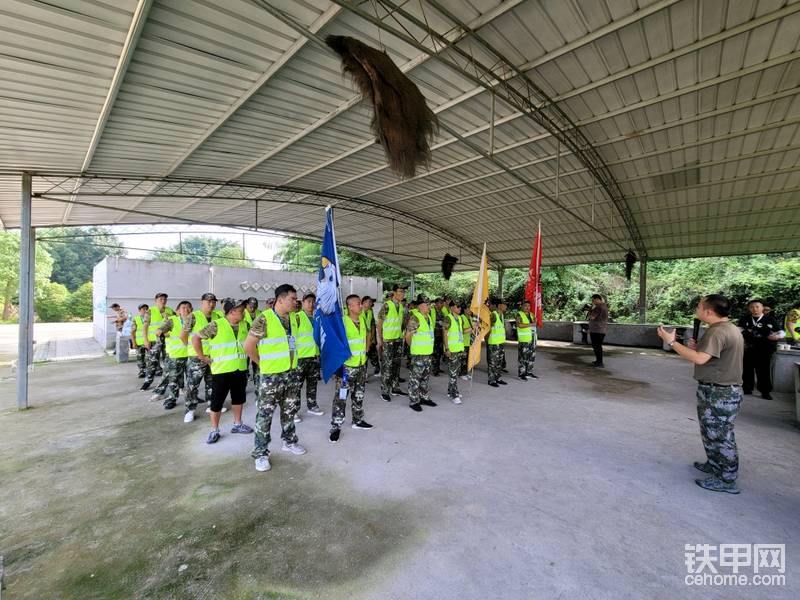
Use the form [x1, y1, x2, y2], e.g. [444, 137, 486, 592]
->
[192, 298, 253, 444]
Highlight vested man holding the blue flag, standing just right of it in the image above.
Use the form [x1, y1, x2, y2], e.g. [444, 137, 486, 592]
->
[329, 294, 372, 444]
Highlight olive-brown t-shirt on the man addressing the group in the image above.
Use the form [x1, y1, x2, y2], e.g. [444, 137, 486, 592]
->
[694, 321, 744, 385]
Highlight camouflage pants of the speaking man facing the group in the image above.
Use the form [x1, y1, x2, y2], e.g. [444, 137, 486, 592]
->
[697, 383, 742, 482]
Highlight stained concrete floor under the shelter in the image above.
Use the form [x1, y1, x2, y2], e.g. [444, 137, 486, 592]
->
[0, 343, 800, 600]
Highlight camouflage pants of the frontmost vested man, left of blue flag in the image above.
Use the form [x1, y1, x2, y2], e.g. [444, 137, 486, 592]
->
[253, 371, 300, 458]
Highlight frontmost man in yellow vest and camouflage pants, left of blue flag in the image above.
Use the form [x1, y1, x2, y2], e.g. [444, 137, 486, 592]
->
[245, 283, 306, 472]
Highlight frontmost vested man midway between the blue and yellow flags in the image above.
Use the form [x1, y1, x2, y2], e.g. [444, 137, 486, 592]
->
[405, 294, 436, 412]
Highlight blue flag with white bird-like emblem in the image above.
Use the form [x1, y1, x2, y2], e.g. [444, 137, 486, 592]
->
[314, 206, 350, 383]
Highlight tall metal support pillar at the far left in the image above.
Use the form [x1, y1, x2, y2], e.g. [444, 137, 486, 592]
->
[17, 173, 36, 410]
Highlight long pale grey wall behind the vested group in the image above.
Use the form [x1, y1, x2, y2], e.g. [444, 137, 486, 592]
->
[93, 257, 383, 348]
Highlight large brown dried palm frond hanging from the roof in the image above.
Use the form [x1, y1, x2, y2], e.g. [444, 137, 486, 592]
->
[325, 35, 438, 178]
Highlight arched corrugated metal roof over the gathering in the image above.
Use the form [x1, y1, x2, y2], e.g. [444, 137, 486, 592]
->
[0, 0, 800, 272]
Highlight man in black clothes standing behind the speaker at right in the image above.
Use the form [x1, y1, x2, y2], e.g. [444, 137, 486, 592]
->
[737, 300, 783, 400]
